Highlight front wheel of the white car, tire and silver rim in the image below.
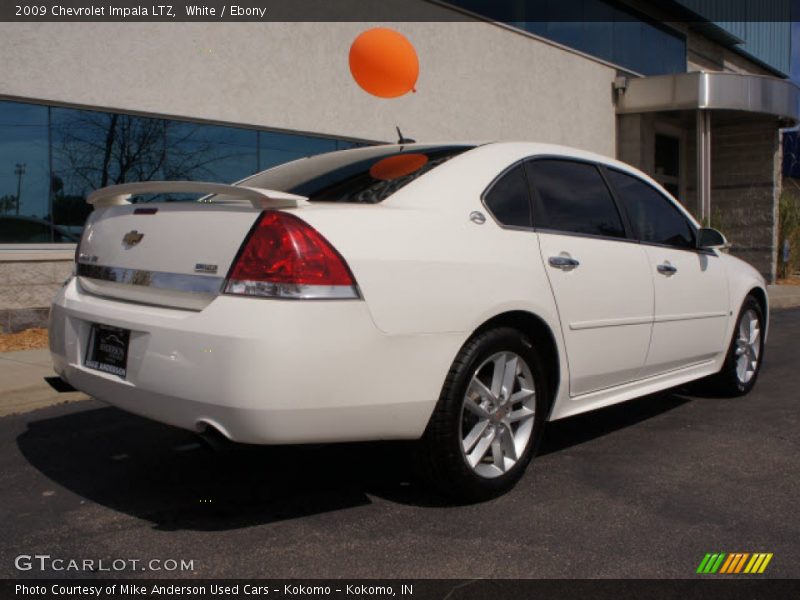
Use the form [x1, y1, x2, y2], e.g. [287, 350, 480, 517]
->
[708, 296, 764, 396]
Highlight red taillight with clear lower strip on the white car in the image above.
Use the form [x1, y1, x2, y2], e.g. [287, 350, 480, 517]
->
[225, 210, 360, 299]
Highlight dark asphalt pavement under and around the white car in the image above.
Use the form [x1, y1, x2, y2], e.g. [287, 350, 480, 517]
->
[0, 310, 800, 578]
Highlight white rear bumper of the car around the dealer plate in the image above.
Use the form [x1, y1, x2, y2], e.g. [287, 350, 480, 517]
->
[50, 280, 463, 444]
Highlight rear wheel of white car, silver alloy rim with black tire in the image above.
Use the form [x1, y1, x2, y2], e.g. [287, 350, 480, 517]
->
[421, 327, 547, 501]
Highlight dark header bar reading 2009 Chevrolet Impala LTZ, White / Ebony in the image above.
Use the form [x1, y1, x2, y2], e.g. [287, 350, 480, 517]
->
[0, 0, 797, 22]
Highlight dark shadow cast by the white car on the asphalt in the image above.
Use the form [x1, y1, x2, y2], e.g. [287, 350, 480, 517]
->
[17, 394, 688, 531]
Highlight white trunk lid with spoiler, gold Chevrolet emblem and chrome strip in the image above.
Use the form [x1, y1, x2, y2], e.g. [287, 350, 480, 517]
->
[76, 182, 304, 310]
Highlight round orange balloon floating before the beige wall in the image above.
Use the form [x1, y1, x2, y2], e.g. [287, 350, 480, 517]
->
[350, 27, 419, 98]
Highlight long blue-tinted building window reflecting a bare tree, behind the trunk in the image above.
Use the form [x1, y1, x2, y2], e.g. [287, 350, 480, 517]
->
[0, 101, 376, 244]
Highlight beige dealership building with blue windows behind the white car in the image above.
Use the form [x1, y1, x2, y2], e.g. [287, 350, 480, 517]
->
[0, 0, 799, 331]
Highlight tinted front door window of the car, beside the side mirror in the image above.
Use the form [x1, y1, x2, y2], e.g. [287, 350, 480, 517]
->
[607, 169, 694, 248]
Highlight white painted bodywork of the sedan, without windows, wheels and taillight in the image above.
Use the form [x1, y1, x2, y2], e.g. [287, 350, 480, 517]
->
[50, 143, 766, 443]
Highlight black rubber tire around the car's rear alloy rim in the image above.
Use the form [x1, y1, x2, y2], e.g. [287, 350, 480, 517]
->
[419, 327, 548, 502]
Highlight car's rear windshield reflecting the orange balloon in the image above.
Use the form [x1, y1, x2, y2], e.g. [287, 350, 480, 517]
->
[239, 145, 475, 204]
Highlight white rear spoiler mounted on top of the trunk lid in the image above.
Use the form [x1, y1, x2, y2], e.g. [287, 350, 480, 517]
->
[86, 181, 308, 208]
